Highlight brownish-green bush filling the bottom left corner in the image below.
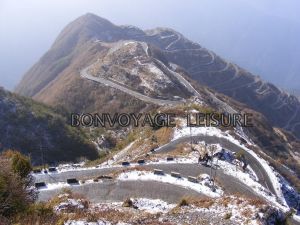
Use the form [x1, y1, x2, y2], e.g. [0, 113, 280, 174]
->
[0, 150, 62, 225]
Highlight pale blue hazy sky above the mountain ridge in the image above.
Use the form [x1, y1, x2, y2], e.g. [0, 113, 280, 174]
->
[0, 0, 300, 93]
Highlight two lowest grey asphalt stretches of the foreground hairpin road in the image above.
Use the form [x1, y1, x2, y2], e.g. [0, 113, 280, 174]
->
[34, 163, 259, 202]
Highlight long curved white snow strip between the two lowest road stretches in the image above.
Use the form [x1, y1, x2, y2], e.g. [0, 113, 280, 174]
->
[117, 171, 223, 198]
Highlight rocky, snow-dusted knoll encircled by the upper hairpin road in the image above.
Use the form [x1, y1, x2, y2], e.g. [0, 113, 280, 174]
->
[90, 41, 191, 100]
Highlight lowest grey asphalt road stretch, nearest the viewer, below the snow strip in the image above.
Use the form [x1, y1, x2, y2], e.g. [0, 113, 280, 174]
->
[39, 180, 204, 203]
